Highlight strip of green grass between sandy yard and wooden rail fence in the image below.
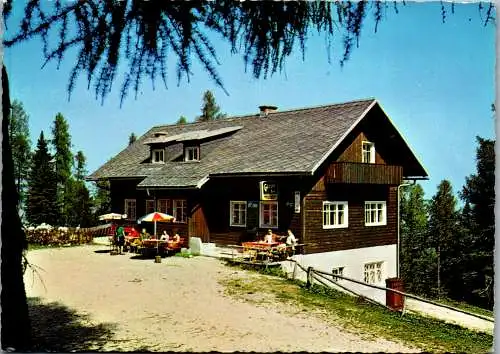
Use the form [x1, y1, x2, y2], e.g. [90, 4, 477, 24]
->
[222, 264, 493, 353]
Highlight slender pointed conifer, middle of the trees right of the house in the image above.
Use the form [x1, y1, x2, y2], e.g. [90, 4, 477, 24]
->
[429, 180, 460, 297]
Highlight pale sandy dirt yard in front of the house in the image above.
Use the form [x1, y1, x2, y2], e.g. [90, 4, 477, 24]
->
[25, 245, 414, 352]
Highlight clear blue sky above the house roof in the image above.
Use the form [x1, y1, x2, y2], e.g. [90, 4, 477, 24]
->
[5, 1, 495, 202]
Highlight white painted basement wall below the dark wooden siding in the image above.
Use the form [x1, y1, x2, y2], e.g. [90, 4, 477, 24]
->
[283, 244, 397, 304]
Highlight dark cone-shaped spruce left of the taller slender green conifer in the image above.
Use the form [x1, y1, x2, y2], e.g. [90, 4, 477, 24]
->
[26, 131, 58, 225]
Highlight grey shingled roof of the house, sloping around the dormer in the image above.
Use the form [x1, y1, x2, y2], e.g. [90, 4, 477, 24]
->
[89, 99, 426, 187]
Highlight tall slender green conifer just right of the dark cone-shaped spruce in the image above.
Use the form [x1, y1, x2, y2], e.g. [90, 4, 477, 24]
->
[51, 113, 73, 225]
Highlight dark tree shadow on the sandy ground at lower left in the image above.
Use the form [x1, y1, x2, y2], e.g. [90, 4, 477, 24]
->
[28, 297, 116, 352]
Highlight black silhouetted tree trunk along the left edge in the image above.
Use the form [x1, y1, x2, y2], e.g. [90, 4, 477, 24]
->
[1, 66, 31, 351]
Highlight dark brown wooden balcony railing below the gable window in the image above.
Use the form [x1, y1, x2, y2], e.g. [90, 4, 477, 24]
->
[325, 162, 403, 184]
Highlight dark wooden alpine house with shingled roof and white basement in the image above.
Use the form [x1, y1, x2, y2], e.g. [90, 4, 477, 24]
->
[88, 99, 427, 284]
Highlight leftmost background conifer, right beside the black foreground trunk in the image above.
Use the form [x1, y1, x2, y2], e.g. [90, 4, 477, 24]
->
[9, 100, 31, 216]
